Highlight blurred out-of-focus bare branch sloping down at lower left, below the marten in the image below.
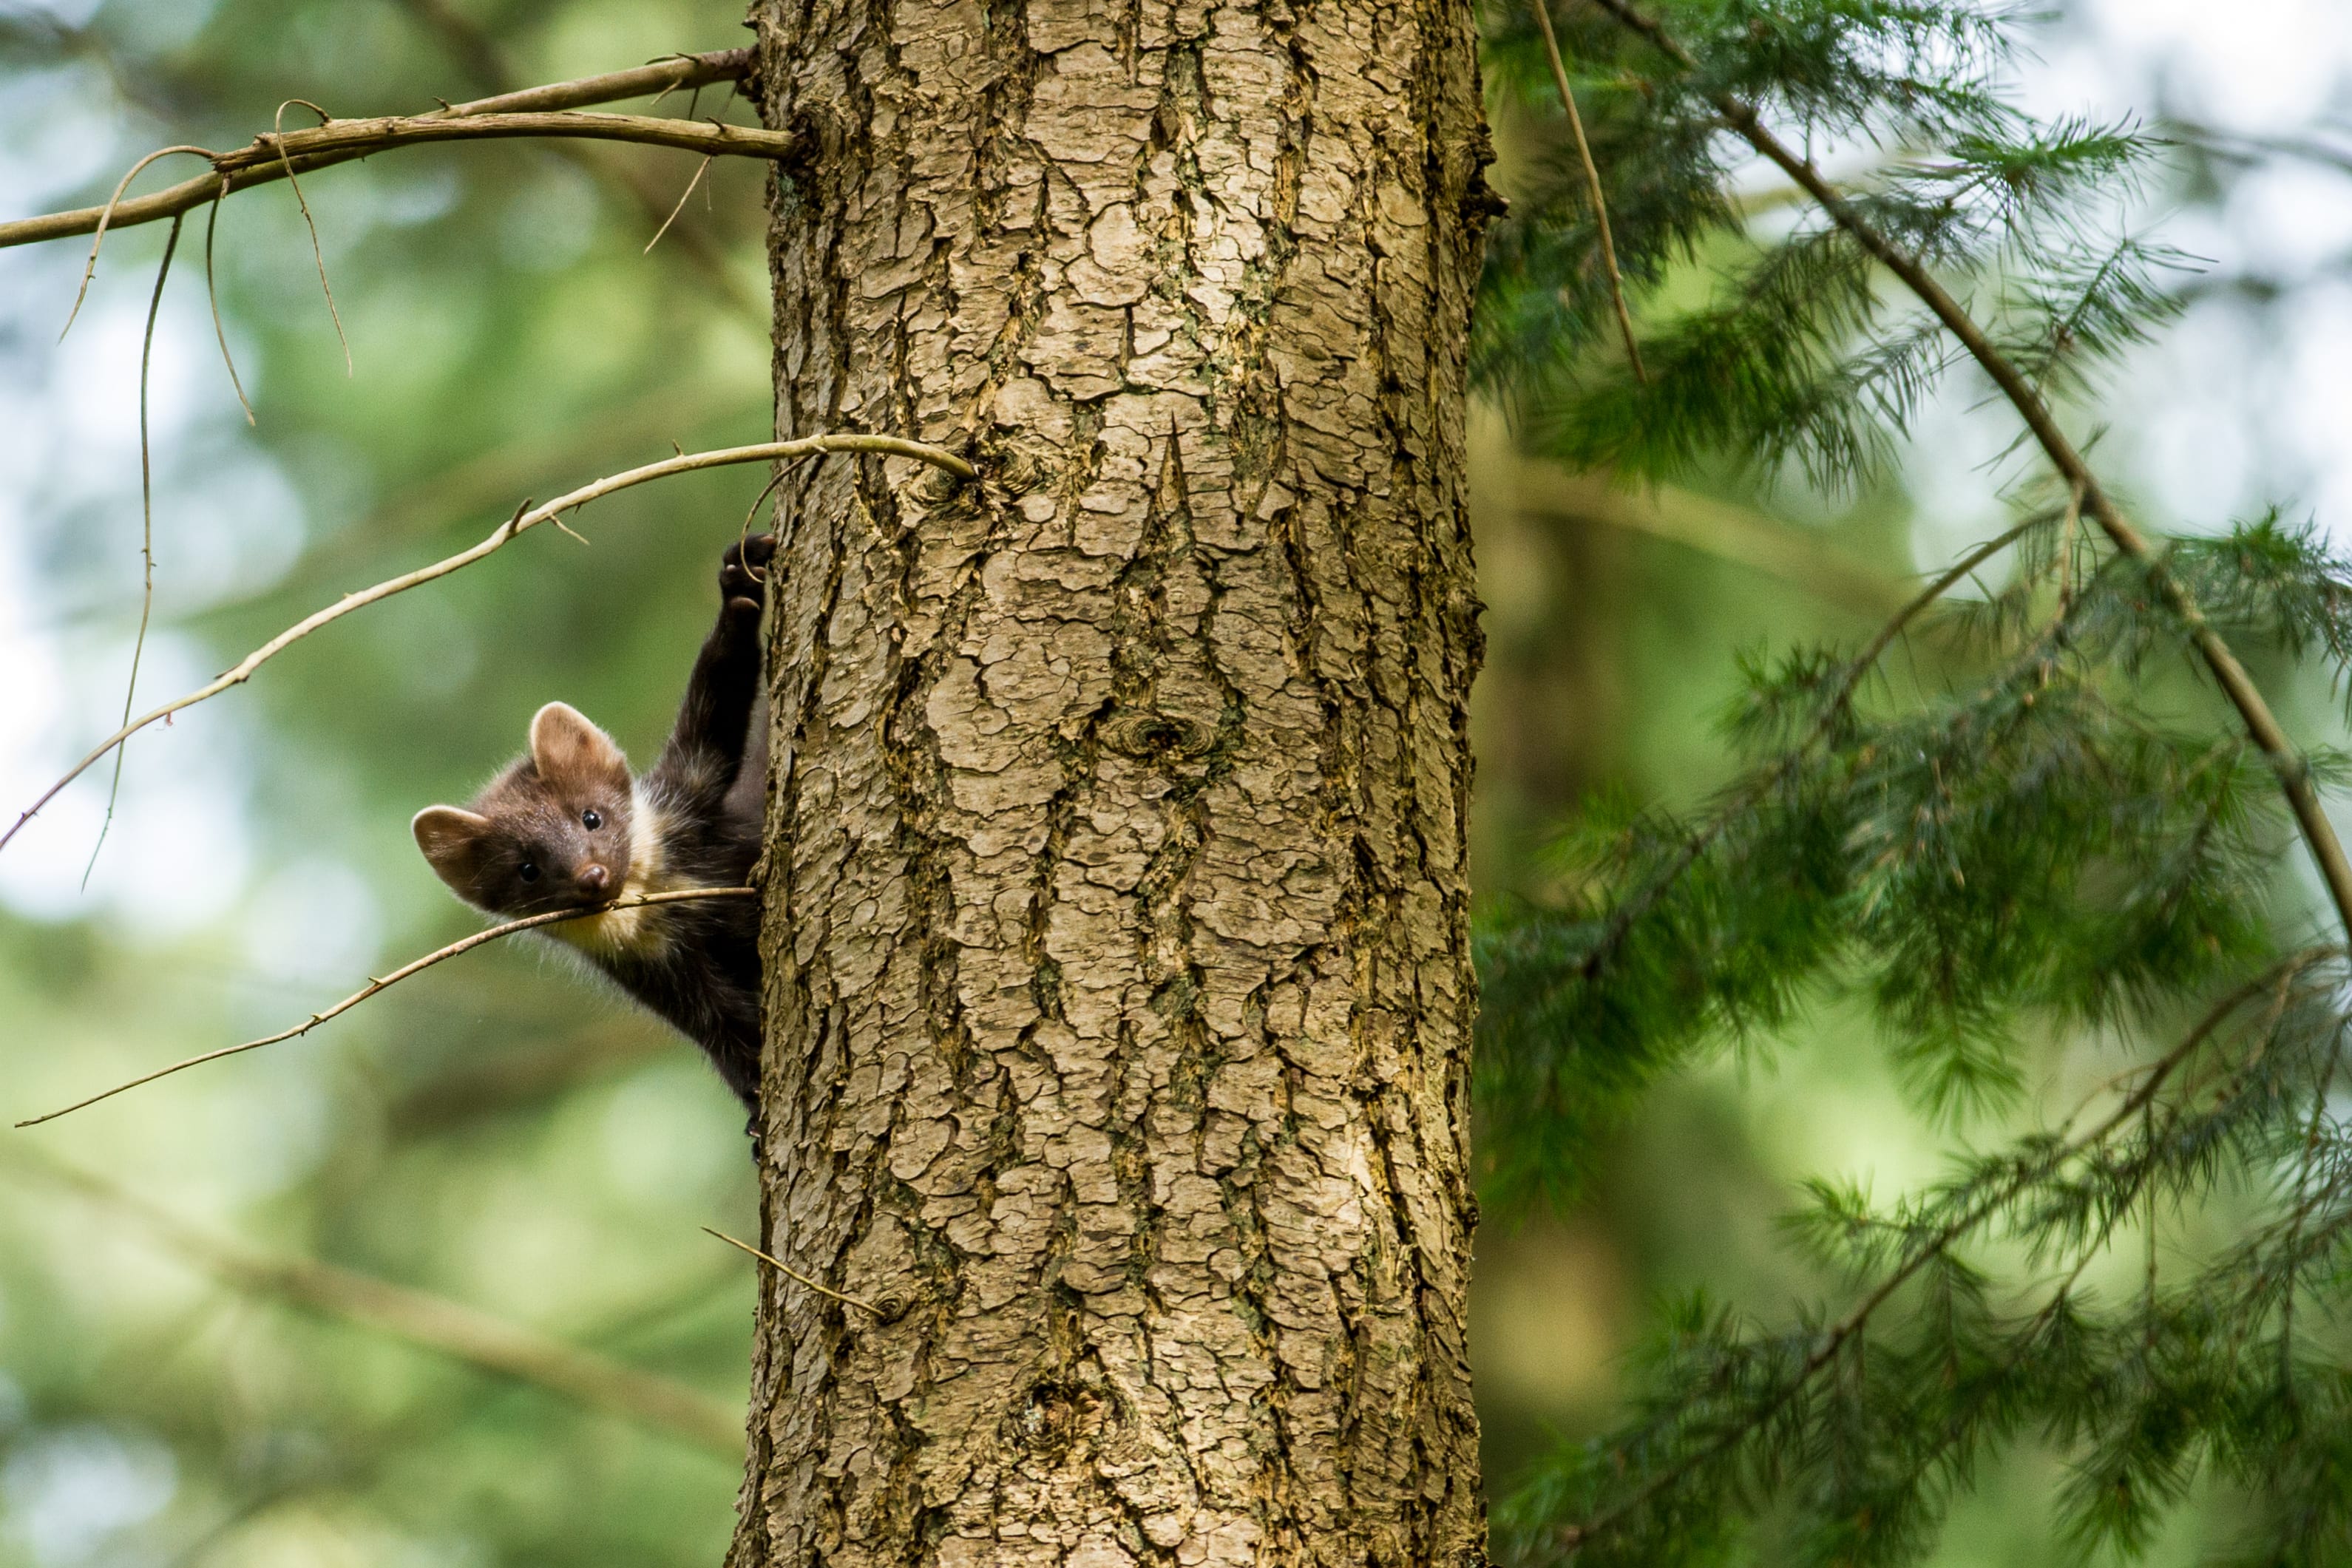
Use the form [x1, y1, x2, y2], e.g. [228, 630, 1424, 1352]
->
[7, 1145, 743, 1455]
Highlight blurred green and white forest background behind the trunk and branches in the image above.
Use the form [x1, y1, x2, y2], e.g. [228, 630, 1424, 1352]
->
[0, 0, 2352, 1568]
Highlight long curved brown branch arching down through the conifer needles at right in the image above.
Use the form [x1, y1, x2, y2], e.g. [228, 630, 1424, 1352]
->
[1593, 0, 2352, 931]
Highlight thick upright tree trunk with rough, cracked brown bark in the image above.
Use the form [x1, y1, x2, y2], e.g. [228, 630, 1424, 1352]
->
[729, 0, 1491, 1568]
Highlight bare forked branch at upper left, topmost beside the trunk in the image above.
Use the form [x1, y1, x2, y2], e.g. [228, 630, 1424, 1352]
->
[0, 50, 762, 247]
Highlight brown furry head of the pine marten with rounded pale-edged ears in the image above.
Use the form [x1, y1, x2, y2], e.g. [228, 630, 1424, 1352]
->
[409, 703, 635, 914]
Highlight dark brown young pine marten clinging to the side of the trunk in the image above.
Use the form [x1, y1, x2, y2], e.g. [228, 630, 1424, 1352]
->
[409, 534, 776, 1112]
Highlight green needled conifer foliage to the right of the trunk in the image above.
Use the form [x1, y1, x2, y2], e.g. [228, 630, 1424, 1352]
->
[1474, 0, 2352, 1566]
